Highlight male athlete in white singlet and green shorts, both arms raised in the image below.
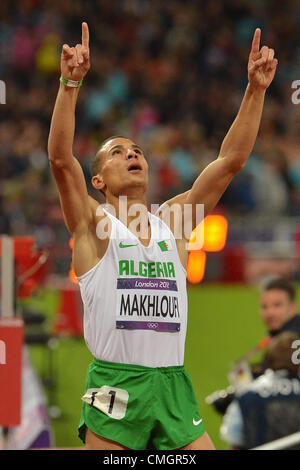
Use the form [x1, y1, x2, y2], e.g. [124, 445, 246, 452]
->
[48, 23, 277, 450]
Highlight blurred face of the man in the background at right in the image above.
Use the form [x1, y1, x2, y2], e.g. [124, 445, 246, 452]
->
[260, 289, 297, 331]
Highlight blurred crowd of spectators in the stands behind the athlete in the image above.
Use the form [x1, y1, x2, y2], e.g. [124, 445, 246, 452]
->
[0, 0, 300, 264]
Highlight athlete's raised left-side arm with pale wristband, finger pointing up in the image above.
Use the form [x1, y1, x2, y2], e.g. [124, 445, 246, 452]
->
[48, 23, 97, 234]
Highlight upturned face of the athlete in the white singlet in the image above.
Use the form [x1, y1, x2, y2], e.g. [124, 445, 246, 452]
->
[95, 138, 148, 195]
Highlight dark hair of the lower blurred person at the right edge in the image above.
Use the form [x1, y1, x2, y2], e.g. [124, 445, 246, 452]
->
[266, 331, 300, 373]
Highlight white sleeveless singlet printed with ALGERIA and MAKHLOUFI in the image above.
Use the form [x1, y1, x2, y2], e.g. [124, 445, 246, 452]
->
[77, 209, 187, 367]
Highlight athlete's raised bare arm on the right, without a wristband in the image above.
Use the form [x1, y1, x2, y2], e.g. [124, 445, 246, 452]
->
[158, 29, 277, 227]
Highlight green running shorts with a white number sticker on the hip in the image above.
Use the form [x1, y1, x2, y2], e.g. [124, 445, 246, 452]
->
[78, 359, 205, 450]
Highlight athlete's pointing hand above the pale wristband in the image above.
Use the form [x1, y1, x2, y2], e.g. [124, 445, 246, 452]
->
[60, 23, 90, 81]
